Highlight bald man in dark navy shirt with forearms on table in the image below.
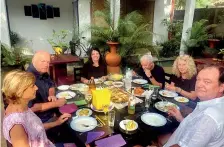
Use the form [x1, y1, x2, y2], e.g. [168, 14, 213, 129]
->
[27, 51, 71, 142]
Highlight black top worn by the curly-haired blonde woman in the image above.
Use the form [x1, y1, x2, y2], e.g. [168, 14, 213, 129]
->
[171, 75, 196, 92]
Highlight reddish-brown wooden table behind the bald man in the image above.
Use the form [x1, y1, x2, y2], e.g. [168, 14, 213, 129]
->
[50, 54, 81, 84]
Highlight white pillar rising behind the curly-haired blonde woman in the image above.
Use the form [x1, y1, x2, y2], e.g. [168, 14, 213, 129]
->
[180, 0, 195, 55]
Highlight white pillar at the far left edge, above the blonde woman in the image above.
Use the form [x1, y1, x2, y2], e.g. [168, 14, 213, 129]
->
[0, 0, 11, 47]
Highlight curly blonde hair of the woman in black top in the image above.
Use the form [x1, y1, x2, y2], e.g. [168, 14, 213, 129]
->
[173, 55, 197, 79]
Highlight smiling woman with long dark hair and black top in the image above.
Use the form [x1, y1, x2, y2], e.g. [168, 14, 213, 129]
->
[81, 48, 107, 84]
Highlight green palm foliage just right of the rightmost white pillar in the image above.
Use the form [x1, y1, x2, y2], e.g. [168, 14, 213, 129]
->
[185, 19, 209, 55]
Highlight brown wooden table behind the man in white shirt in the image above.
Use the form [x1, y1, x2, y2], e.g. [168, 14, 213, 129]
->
[194, 58, 224, 71]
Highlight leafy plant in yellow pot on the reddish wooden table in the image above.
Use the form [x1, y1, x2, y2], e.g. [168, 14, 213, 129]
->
[47, 30, 70, 55]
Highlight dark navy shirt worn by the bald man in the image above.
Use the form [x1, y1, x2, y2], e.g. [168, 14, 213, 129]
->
[27, 64, 55, 123]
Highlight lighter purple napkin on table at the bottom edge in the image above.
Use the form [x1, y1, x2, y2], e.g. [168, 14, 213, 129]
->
[95, 134, 126, 147]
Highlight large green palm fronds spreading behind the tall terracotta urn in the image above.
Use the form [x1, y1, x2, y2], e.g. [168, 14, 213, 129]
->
[90, 9, 152, 57]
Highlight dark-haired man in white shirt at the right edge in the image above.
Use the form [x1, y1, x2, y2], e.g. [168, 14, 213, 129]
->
[164, 66, 224, 147]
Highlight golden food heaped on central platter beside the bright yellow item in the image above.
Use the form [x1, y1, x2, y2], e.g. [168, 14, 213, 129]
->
[110, 88, 130, 103]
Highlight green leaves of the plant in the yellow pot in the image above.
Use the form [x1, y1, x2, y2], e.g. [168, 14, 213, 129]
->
[47, 30, 70, 48]
